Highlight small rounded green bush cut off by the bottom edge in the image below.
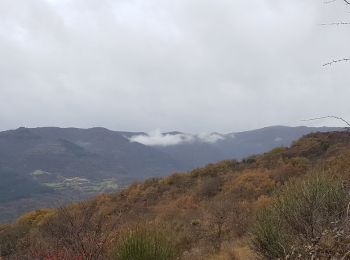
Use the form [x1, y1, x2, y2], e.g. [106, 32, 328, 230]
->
[114, 227, 177, 260]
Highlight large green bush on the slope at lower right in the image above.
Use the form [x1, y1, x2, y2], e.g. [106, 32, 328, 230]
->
[253, 173, 348, 258]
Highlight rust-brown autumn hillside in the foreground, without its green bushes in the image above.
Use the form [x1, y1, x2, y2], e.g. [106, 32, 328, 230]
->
[0, 132, 350, 259]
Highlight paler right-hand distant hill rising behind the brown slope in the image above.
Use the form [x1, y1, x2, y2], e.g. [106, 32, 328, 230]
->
[154, 126, 341, 168]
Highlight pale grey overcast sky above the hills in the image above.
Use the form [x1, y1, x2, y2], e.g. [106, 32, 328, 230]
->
[0, 0, 350, 133]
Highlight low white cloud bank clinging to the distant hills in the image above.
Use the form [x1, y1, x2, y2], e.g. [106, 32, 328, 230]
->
[129, 129, 224, 146]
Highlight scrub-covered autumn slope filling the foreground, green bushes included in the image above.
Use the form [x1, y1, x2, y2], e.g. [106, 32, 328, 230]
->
[0, 132, 350, 259]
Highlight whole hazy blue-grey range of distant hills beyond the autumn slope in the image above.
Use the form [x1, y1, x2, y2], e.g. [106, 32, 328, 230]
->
[0, 126, 337, 221]
